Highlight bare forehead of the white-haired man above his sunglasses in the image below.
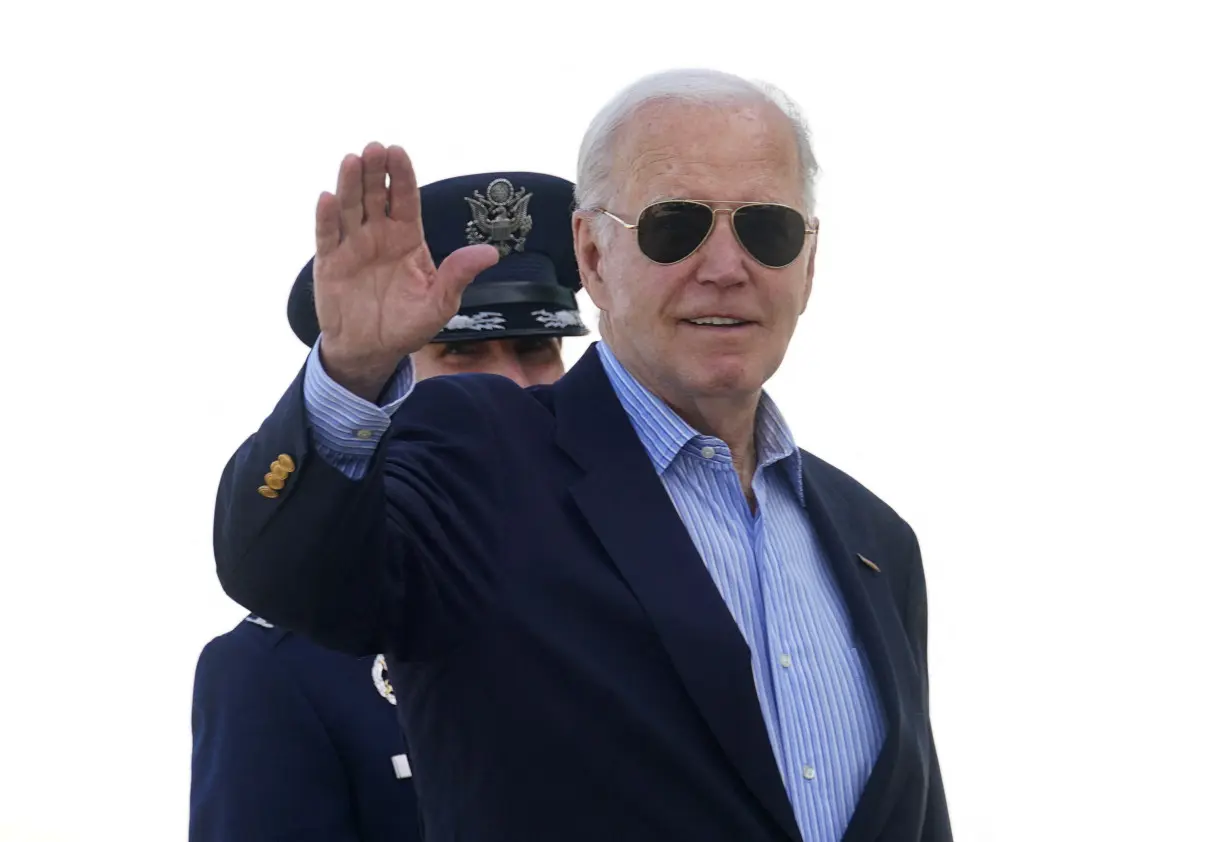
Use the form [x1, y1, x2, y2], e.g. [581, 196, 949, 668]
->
[613, 103, 802, 203]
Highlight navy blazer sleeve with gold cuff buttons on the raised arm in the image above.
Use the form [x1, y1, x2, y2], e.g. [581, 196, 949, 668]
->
[214, 358, 511, 660]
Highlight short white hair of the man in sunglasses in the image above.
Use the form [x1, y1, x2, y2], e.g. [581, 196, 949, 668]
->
[577, 69, 820, 215]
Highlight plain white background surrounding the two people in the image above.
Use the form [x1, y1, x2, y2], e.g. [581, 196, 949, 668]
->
[0, 0, 1230, 842]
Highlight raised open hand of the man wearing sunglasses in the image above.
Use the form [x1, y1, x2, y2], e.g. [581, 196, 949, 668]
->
[315, 143, 499, 401]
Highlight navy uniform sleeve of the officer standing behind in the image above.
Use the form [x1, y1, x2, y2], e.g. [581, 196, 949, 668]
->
[188, 633, 358, 842]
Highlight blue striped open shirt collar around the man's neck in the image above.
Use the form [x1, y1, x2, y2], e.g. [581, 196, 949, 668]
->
[595, 340, 803, 503]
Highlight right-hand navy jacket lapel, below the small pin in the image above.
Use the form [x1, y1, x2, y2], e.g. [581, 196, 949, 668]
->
[803, 460, 908, 842]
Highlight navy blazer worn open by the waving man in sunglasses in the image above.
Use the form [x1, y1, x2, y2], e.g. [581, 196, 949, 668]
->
[214, 348, 951, 842]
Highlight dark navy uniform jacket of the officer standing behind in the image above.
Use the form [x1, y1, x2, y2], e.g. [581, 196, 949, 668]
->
[188, 617, 419, 842]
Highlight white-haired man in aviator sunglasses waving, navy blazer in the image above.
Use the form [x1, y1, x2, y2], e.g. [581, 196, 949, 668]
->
[215, 71, 951, 842]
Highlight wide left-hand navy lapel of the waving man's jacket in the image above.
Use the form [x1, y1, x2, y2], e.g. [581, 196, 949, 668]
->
[554, 348, 801, 842]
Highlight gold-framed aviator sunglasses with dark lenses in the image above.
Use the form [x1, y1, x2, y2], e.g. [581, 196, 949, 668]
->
[593, 199, 817, 269]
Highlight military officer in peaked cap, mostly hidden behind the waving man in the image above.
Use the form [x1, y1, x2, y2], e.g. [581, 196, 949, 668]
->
[188, 172, 587, 842]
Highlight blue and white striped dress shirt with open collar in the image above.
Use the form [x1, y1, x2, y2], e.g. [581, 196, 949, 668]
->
[304, 342, 884, 842]
